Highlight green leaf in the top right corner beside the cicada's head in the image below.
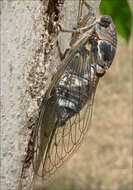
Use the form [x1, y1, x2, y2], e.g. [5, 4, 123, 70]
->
[99, 0, 133, 42]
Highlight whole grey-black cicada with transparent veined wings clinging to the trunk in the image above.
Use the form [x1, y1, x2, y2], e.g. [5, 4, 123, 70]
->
[19, 0, 117, 187]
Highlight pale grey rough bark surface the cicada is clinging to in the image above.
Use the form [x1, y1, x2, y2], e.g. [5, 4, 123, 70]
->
[0, 0, 100, 190]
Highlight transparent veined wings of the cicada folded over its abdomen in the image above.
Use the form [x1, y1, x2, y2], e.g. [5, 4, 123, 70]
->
[33, 46, 98, 183]
